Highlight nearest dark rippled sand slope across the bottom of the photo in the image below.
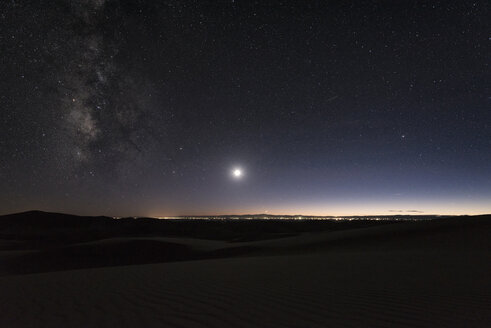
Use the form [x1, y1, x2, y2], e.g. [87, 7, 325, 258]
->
[0, 252, 491, 327]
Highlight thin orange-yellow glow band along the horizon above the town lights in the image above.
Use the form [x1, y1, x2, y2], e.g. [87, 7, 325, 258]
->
[8, 199, 491, 218]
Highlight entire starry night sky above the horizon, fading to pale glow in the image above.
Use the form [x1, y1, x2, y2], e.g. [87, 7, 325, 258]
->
[0, 0, 491, 216]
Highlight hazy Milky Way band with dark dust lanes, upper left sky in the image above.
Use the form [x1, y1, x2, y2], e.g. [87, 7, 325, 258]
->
[59, 1, 143, 167]
